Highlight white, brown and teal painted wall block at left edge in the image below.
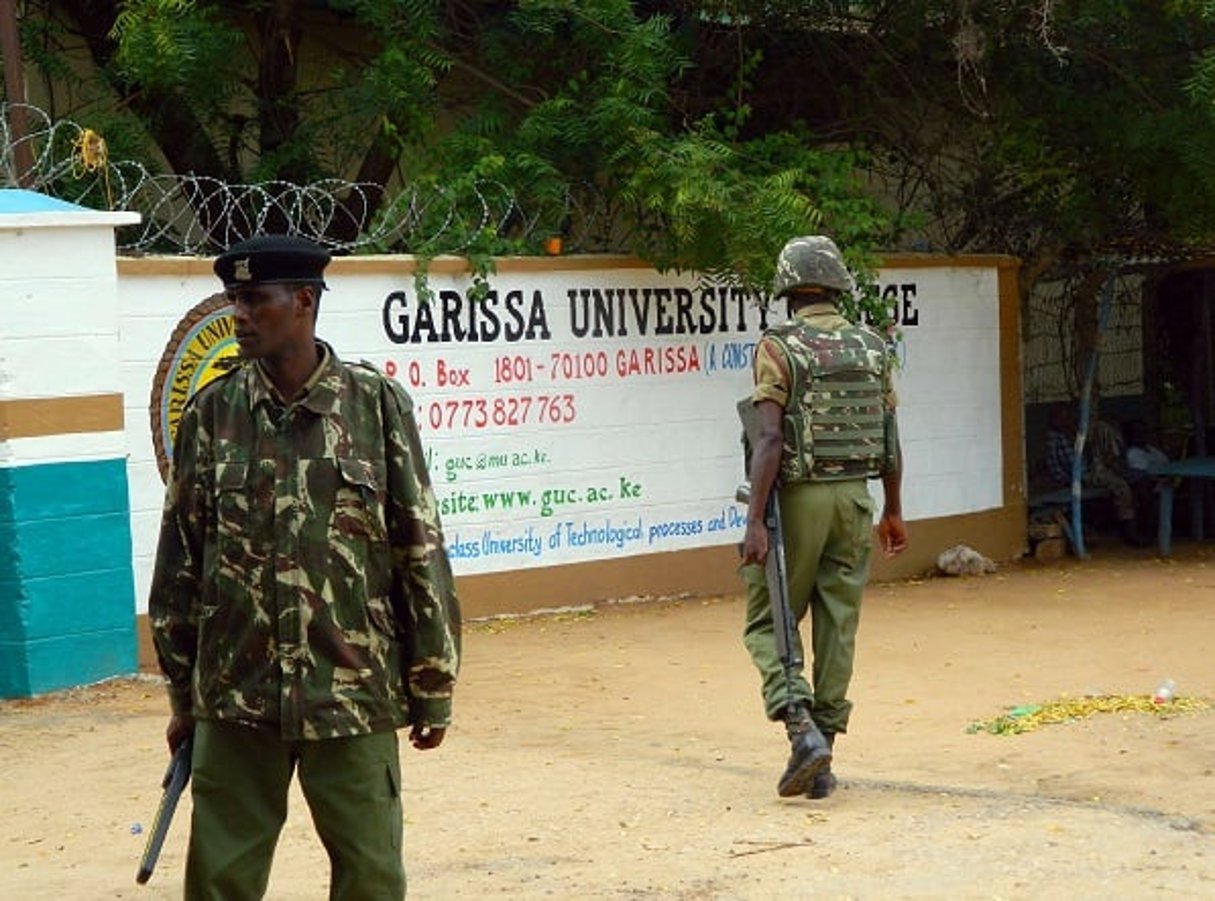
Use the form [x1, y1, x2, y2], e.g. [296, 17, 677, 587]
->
[0, 189, 137, 697]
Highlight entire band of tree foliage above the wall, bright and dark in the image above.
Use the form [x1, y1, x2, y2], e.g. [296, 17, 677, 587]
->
[16, 0, 1215, 310]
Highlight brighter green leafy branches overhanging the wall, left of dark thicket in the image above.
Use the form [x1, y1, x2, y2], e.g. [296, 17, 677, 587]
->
[18, 0, 886, 313]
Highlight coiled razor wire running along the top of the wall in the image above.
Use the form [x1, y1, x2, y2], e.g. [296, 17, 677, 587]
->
[0, 103, 612, 255]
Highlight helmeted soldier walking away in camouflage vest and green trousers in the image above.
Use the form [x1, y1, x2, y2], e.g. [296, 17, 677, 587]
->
[740, 236, 906, 798]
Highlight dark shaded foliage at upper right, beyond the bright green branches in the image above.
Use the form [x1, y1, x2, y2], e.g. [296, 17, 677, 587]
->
[701, 0, 1215, 272]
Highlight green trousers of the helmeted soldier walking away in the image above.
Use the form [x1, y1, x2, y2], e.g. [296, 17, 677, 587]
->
[739, 480, 874, 732]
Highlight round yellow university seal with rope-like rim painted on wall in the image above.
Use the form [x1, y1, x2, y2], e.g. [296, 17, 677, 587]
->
[148, 294, 241, 481]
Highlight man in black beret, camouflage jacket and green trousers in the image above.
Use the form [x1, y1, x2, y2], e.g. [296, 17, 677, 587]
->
[148, 236, 460, 901]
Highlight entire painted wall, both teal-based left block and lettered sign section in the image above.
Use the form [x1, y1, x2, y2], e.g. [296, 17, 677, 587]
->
[0, 210, 1025, 693]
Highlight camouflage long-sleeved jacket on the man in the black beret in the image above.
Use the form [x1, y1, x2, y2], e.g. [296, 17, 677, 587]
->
[148, 345, 460, 738]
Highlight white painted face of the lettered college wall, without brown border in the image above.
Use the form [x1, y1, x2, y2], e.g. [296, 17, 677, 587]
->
[119, 261, 1002, 612]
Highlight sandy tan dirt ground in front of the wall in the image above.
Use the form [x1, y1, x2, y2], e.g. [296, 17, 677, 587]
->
[0, 545, 1215, 901]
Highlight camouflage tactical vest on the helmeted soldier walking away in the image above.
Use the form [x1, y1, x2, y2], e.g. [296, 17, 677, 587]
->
[765, 318, 898, 485]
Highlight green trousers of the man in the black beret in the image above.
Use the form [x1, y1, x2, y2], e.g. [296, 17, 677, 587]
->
[185, 721, 405, 901]
